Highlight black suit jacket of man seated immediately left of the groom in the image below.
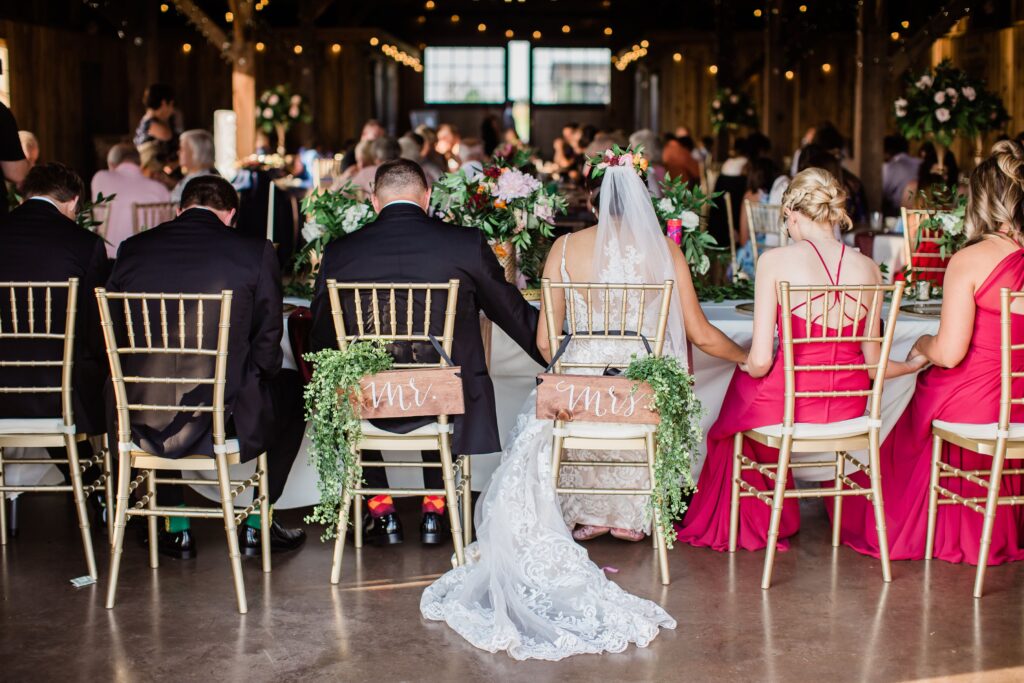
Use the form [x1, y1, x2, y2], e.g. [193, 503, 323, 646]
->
[108, 209, 284, 460]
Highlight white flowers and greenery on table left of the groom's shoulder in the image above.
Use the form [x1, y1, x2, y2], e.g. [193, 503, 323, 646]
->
[290, 183, 377, 295]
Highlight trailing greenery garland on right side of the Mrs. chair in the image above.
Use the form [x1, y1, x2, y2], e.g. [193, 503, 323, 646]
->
[625, 355, 705, 548]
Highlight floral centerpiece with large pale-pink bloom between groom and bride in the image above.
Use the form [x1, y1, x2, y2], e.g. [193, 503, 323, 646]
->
[430, 157, 567, 283]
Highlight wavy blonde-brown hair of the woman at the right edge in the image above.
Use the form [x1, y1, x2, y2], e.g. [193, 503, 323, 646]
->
[966, 140, 1024, 246]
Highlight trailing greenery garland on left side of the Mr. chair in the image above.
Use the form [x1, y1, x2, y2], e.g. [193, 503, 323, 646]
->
[303, 340, 393, 541]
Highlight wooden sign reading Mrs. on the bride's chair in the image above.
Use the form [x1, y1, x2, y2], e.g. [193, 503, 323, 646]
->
[537, 374, 660, 425]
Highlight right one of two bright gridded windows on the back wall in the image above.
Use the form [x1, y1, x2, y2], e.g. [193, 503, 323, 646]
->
[534, 47, 611, 104]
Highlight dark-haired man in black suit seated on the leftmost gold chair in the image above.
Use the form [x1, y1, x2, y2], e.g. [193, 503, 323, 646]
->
[0, 164, 109, 501]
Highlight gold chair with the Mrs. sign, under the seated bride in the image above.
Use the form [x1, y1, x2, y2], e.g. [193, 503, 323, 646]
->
[541, 278, 675, 585]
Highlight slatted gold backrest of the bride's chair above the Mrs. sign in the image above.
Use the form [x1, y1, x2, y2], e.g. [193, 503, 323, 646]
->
[541, 278, 675, 373]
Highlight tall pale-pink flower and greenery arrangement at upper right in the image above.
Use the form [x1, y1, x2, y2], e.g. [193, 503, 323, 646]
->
[893, 59, 1009, 167]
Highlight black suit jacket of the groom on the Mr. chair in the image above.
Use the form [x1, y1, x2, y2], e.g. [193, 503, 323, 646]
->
[312, 204, 543, 455]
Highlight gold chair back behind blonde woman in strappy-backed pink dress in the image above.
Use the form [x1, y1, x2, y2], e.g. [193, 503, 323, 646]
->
[778, 282, 904, 427]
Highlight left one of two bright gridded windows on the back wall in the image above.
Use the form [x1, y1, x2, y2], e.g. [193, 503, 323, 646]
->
[423, 47, 505, 104]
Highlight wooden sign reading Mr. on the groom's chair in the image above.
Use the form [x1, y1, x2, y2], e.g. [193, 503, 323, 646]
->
[348, 367, 466, 420]
